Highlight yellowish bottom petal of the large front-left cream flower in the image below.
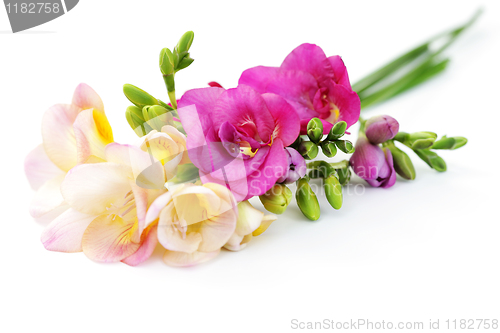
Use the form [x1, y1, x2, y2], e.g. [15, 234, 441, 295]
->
[82, 214, 140, 262]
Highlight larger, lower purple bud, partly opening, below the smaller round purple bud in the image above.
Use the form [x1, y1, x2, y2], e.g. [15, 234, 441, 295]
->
[350, 135, 396, 188]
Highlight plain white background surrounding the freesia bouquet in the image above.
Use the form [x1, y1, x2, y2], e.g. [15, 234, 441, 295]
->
[0, 0, 500, 332]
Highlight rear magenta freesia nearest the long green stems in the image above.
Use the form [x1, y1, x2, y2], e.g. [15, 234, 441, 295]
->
[239, 44, 361, 134]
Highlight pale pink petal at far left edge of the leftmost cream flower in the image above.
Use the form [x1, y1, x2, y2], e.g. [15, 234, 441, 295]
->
[24, 144, 64, 191]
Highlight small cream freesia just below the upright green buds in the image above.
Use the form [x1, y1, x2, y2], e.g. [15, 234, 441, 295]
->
[141, 125, 190, 180]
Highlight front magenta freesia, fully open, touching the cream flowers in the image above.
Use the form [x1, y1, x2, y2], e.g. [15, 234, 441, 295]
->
[179, 85, 300, 201]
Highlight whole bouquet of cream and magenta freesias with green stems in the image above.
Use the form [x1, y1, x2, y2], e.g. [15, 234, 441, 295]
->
[25, 10, 477, 266]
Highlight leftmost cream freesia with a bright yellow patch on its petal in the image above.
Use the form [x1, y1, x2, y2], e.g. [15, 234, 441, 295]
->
[24, 83, 113, 218]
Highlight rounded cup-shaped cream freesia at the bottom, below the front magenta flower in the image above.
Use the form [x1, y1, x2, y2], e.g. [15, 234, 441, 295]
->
[146, 183, 238, 266]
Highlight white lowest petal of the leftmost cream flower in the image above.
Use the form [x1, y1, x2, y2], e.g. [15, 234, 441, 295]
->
[29, 174, 65, 218]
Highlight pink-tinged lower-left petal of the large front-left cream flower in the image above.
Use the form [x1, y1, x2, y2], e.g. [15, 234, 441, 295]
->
[42, 208, 96, 252]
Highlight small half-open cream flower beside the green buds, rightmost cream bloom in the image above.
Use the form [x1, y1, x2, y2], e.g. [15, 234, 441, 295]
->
[224, 201, 277, 251]
